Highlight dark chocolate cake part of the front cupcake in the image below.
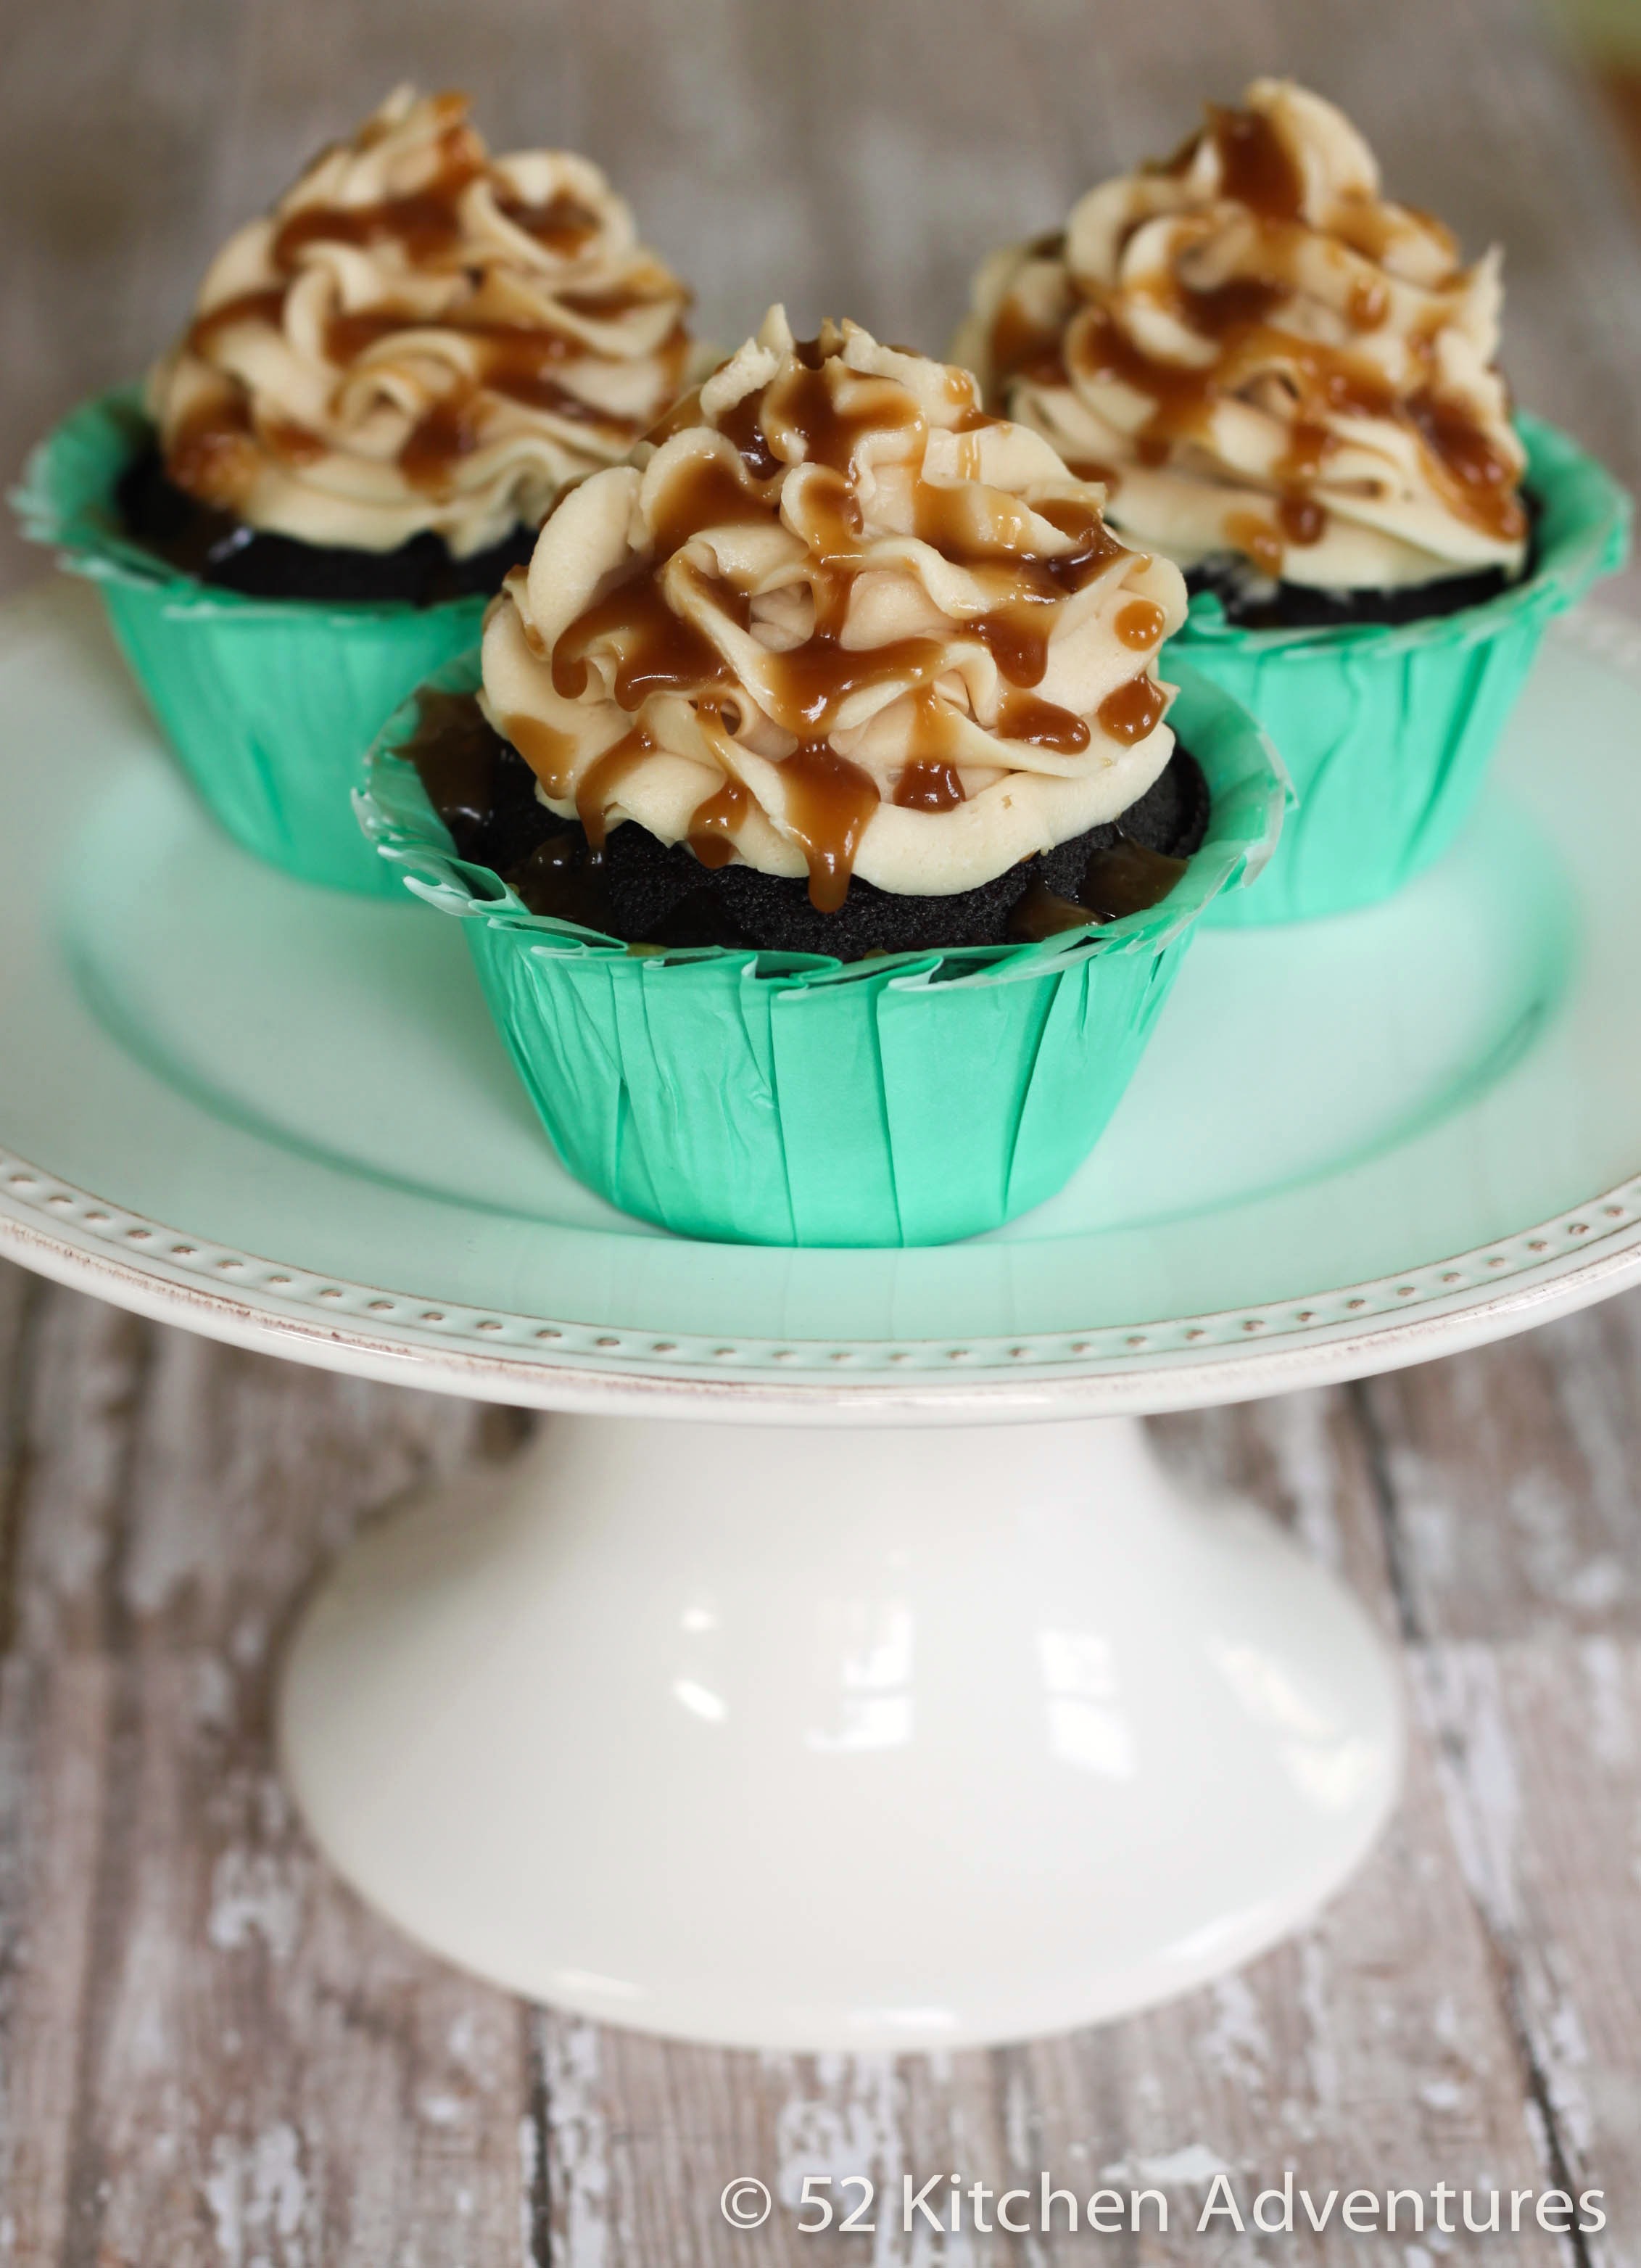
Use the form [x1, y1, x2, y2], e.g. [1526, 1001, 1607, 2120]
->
[401, 694, 1208, 962]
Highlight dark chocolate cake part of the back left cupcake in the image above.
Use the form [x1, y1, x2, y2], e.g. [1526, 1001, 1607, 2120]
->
[115, 442, 535, 606]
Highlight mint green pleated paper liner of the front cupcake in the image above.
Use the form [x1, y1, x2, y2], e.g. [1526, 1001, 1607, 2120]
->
[356, 656, 1287, 1245]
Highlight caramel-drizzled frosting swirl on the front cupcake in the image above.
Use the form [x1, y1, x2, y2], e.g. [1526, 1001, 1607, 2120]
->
[483, 308, 1186, 912]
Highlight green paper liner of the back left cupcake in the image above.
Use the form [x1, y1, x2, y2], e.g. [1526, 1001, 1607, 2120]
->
[12, 390, 485, 896]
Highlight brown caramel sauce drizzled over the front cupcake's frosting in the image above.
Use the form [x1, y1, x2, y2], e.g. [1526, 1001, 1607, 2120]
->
[532, 340, 1167, 918]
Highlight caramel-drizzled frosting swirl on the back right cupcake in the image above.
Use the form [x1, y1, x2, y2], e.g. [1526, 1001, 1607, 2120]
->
[959, 79, 1528, 590]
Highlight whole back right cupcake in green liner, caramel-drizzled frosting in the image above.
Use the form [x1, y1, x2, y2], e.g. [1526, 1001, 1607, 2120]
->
[956, 79, 1625, 921]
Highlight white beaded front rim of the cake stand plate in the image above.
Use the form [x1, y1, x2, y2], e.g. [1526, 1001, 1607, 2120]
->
[0, 1150, 1641, 1381]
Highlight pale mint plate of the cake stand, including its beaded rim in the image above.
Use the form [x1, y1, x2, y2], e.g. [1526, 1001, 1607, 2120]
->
[0, 585, 1641, 1415]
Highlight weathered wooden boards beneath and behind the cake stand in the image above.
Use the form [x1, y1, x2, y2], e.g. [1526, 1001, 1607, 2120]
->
[0, 0, 1641, 2268]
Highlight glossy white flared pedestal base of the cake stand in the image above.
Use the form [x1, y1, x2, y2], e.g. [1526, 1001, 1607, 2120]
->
[281, 1417, 1401, 2050]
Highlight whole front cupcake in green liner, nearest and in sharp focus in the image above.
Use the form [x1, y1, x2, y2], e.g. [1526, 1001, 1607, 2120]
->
[360, 308, 1283, 1243]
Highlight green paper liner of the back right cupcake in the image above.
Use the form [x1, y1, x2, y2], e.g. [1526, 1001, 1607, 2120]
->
[1162, 417, 1629, 928]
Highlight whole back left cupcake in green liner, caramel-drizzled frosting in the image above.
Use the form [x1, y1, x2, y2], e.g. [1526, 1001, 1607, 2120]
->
[20, 91, 689, 889]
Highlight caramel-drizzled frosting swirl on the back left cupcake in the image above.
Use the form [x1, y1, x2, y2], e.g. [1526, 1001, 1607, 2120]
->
[149, 88, 689, 558]
